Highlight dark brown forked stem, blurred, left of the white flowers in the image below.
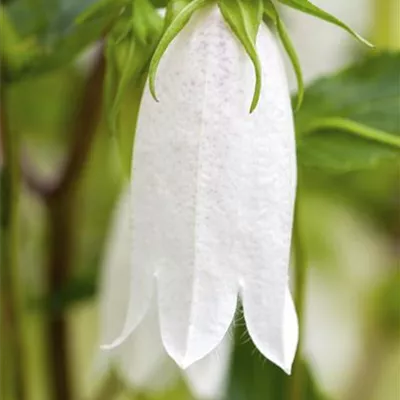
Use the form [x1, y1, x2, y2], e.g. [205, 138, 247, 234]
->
[22, 49, 105, 400]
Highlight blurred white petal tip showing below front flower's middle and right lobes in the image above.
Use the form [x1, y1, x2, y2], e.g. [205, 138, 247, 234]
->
[184, 333, 233, 400]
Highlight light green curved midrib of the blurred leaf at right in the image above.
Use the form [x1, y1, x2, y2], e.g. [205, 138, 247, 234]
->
[300, 117, 400, 149]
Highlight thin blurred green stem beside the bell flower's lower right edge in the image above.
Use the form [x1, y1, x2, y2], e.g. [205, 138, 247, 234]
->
[290, 184, 307, 400]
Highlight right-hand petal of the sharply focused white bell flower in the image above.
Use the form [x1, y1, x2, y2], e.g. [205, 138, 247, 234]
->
[241, 26, 296, 372]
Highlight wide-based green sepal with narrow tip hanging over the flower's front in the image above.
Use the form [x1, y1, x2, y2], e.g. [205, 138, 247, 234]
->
[218, 0, 263, 112]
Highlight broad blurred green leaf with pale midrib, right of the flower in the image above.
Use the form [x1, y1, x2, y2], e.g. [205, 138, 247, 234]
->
[296, 53, 400, 172]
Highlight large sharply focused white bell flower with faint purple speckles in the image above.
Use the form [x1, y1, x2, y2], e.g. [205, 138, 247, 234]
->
[106, 5, 298, 372]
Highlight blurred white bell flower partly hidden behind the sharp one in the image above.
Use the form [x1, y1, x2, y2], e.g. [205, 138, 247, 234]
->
[100, 190, 232, 400]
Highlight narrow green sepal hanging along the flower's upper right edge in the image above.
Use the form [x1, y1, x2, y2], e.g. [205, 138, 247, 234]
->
[264, 0, 304, 111]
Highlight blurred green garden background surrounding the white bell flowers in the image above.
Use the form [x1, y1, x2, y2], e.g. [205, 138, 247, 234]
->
[0, 0, 400, 400]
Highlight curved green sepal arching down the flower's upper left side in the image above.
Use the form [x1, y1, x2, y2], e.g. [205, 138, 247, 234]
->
[149, 0, 212, 101]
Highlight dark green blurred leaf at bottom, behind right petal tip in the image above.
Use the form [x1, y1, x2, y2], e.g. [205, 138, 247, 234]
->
[226, 324, 325, 400]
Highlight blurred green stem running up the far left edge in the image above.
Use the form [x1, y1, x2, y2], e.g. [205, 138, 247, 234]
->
[0, 97, 28, 400]
